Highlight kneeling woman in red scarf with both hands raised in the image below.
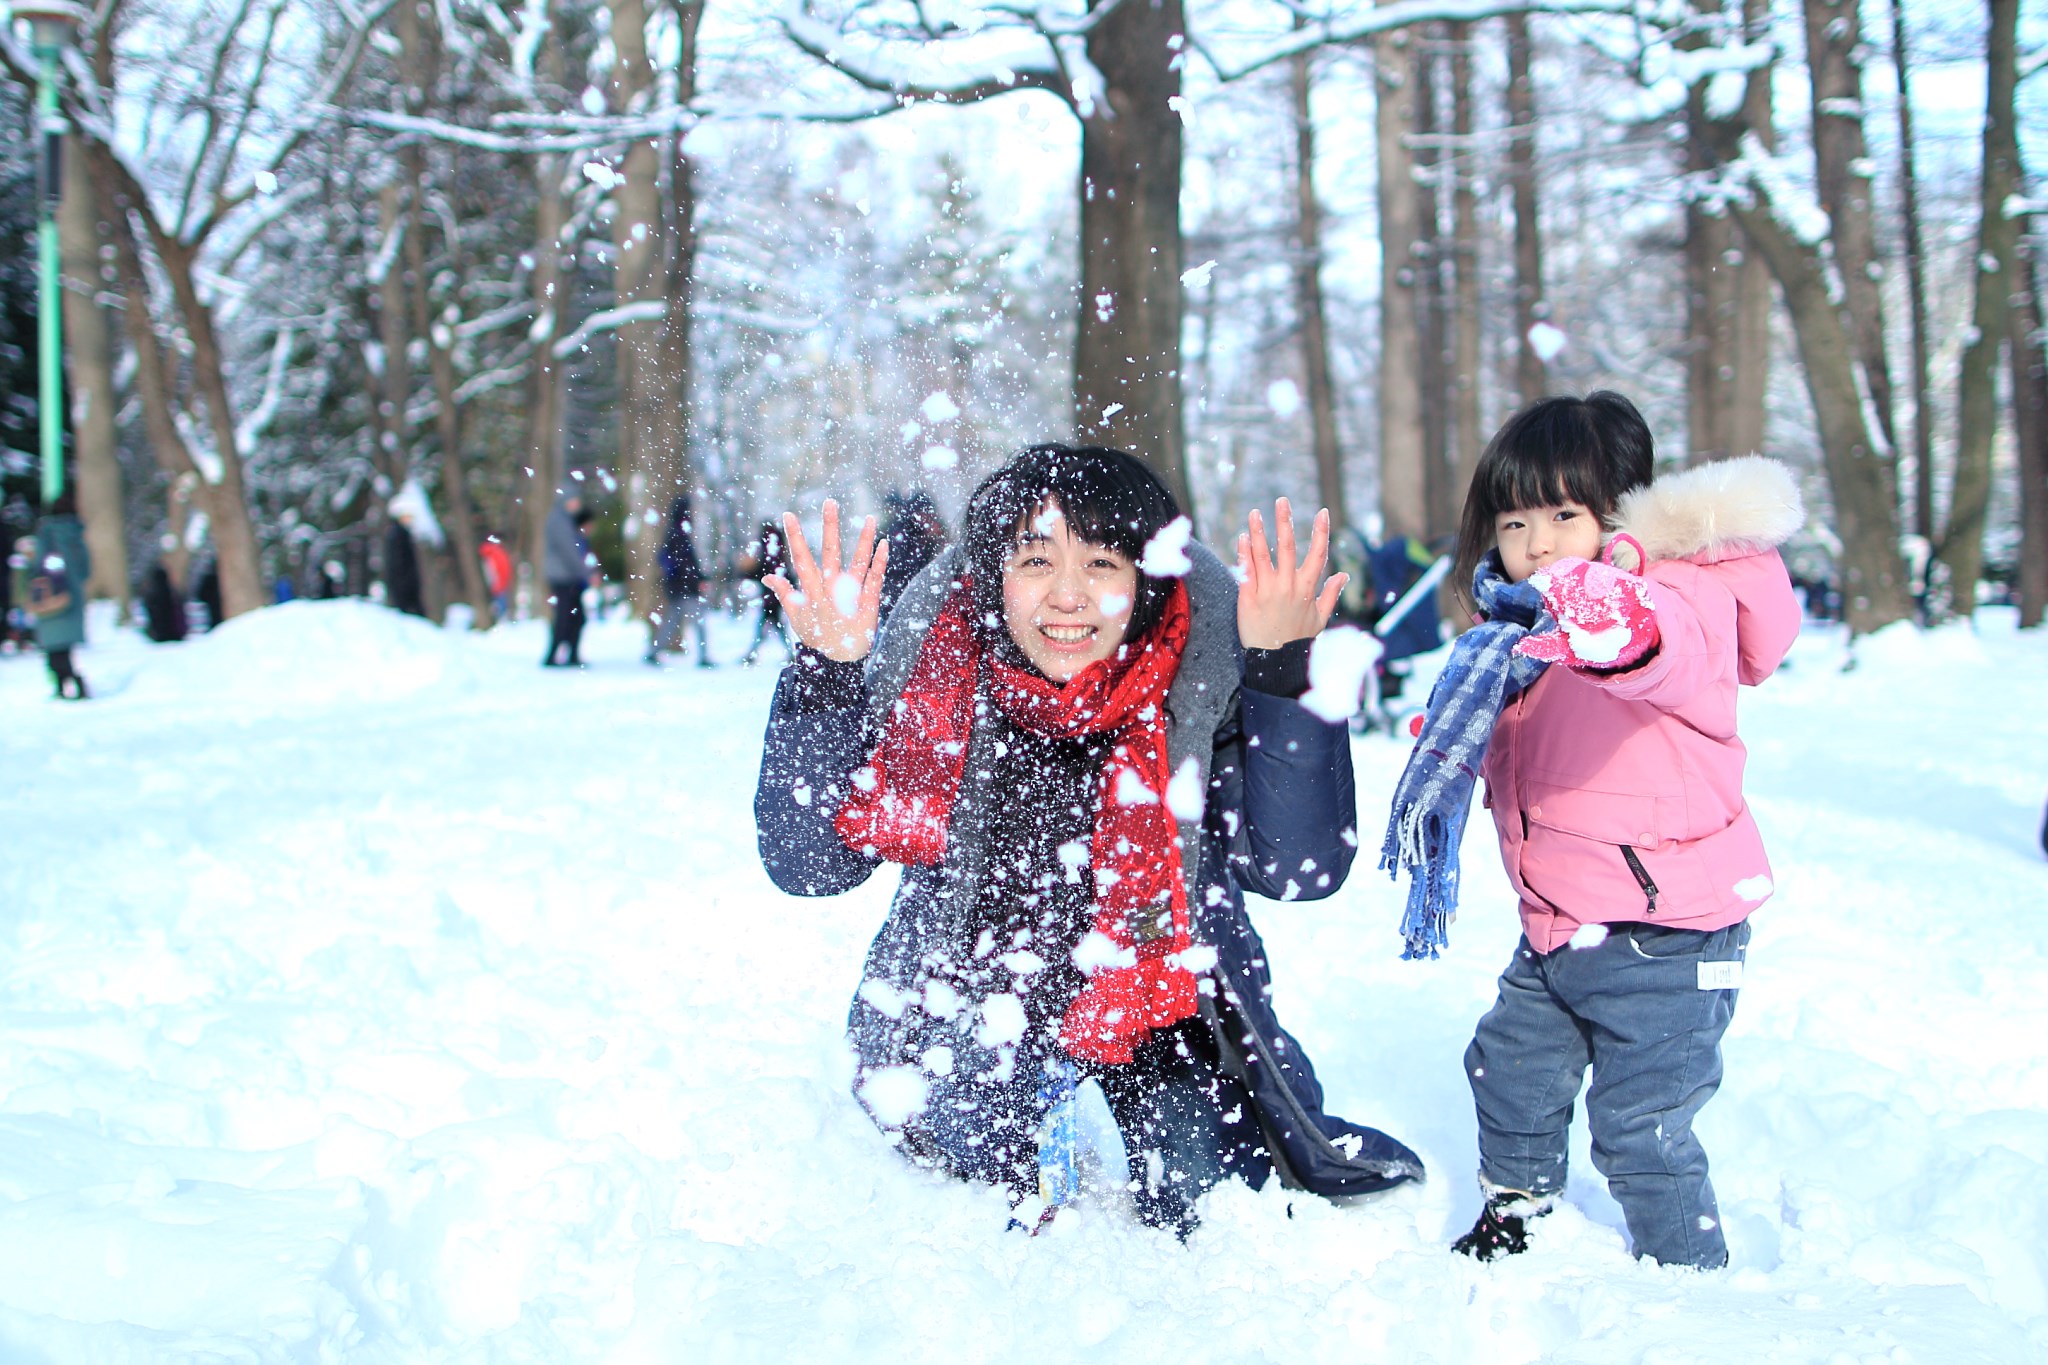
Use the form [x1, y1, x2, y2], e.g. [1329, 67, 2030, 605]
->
[754, 446, 1421, 1236]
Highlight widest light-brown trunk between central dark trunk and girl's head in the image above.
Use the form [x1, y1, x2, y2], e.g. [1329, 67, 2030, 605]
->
[1372, 29, 1430, 538]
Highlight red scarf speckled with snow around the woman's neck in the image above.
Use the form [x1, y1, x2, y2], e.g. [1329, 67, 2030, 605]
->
[838, 583, 1196, 1062]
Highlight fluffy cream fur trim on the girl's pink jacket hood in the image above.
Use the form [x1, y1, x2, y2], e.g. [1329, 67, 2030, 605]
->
[1614, 454, 1806, 565]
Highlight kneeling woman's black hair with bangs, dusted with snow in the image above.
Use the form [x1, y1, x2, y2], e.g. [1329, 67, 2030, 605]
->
[961, 444, 1180, 641]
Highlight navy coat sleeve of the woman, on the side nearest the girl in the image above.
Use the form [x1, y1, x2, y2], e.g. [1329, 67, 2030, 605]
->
[1217, 663, 1358, 900]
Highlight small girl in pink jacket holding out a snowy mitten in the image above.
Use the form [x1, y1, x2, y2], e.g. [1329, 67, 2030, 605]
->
[1382, 393, 1804, 1269]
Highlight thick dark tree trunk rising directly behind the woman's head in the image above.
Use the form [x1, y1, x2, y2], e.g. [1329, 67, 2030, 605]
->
[1073, 0, 1194, 518]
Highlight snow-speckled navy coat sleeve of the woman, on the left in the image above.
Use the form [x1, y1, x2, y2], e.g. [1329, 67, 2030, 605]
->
[754, 649, 881, 896]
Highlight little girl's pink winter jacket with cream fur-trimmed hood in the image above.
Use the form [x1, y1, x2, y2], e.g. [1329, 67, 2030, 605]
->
[1481, 456, 1804, 954]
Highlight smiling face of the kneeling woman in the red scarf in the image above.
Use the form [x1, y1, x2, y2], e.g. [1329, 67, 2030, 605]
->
[1004, 503, 1139, 684]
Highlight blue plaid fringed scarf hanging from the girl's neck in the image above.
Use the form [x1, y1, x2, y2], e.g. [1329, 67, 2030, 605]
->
[1380, 555, 1556, 958]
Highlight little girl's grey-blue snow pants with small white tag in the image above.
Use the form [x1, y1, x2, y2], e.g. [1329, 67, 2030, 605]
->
[1464, 921, 1749, 1269]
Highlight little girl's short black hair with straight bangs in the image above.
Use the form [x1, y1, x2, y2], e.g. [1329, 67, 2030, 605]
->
[1450, 389, 1657, 606]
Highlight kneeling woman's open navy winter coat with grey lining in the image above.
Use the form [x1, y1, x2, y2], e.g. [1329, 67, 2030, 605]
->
[754, 546, 1423, 1195]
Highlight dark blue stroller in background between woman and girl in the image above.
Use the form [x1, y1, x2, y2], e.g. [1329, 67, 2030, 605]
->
[1335, 528, 1450, 737]
